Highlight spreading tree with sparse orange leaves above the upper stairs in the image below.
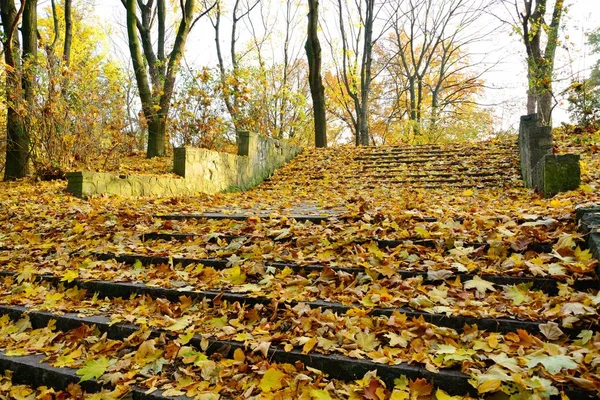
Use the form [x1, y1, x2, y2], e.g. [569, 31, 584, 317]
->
[386, 0, 494, 135]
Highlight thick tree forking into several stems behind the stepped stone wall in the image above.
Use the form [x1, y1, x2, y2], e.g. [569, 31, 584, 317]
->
[121, 0, 216, 158]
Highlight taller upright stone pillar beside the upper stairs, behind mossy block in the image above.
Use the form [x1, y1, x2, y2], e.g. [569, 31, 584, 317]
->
[519, 114, 552, 188]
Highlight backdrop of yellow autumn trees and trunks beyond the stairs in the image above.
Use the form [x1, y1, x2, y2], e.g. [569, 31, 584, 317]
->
[0, 0, 591, 179]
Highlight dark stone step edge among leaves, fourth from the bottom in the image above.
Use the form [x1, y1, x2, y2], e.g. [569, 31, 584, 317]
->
[91, 253, 600, 295]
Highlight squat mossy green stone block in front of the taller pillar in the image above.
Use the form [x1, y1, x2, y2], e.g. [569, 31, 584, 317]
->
[532, 154, 581, 197]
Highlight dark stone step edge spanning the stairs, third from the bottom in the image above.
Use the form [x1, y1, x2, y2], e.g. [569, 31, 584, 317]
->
[0, 271, 593, 338]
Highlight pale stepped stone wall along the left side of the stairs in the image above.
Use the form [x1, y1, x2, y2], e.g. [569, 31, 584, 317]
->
[67, 132, 302, 197]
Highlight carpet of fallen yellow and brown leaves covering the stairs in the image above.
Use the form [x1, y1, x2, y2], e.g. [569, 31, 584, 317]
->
[0, 130, 600, 399]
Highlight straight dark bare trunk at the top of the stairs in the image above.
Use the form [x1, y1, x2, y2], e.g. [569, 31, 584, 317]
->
[305, 0, 327, 147]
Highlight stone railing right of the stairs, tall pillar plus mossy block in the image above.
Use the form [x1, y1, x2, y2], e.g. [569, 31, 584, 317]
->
[519, 114, 581, 197]
